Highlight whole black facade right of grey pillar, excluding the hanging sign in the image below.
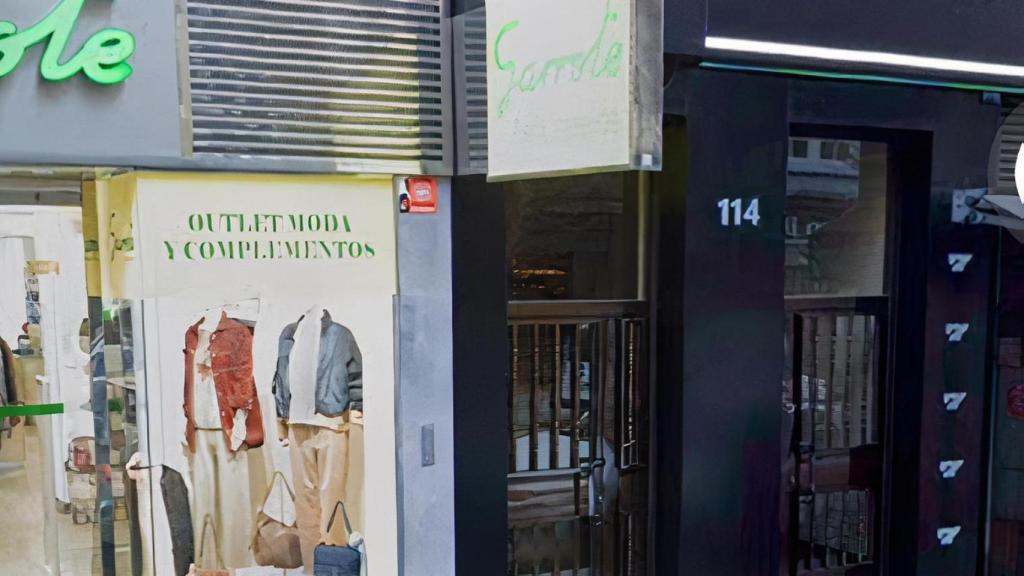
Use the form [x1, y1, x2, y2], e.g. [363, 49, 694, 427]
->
[454, 2, 1020, 576]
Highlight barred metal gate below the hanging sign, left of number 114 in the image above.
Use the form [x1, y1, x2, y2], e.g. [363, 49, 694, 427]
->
[508, 302, 650, 576]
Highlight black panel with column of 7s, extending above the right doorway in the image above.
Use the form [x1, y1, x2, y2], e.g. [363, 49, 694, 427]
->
[791, 81, 999, 575]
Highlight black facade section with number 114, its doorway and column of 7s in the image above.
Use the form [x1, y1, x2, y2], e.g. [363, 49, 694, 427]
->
[654, 70, 1000, 574]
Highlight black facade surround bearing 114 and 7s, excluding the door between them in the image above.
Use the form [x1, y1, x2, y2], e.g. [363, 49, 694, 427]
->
[653, 70, 999, 576]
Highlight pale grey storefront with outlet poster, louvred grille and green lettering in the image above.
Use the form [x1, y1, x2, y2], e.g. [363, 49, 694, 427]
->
[0, 0, 454, 575]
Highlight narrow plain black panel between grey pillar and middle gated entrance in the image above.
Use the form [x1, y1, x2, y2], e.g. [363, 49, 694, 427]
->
[452, 176, 509, 576]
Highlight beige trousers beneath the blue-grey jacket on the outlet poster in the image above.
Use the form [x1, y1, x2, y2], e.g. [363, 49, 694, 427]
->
[288, 414, 362, 574]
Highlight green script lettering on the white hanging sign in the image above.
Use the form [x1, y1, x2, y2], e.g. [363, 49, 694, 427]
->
[494, 0, 624, 118]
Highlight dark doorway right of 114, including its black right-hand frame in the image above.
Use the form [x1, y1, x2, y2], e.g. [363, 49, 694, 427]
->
[780, 126, 929, 576]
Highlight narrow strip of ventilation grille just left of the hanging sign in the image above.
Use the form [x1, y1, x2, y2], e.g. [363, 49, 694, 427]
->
[455, 8, 487, 174]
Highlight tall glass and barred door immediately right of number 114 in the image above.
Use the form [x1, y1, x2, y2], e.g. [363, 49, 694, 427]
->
[781, 137, 891, 576]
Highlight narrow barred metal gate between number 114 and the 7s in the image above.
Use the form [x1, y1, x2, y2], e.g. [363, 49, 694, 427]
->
[787, 298, 887, 576]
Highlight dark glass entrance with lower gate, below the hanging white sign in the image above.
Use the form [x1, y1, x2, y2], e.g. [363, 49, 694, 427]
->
[504, 174, 650, 576]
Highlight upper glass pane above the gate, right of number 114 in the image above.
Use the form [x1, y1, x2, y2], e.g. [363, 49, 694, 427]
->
[785, 139, 889, 296]
